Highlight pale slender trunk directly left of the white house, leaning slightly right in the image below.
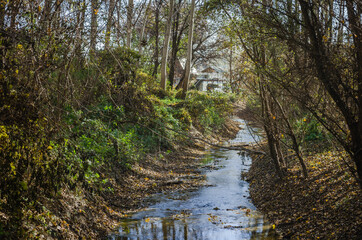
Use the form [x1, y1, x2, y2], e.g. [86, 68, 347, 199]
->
[182, 0, 195, 98]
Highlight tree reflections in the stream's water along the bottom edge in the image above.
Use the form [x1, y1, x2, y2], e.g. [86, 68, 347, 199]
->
[112, 211, 276, 240]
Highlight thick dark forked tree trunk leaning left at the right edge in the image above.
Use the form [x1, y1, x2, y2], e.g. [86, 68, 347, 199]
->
[299, 0, 362, 188]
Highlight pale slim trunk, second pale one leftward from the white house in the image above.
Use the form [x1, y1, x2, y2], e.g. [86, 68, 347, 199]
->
[161, 0, 174, 90]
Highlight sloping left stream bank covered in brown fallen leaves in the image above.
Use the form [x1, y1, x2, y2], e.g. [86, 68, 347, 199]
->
[25, 110, 243, 239]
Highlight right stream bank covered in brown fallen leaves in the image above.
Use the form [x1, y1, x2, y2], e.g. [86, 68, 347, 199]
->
[241, 108, 362, 240]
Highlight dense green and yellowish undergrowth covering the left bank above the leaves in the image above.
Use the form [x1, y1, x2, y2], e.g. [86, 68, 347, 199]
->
[0, 43, 234, 238]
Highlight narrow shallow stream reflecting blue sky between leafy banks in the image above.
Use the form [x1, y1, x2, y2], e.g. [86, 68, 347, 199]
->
[110, 120, 277, 240]
